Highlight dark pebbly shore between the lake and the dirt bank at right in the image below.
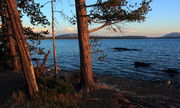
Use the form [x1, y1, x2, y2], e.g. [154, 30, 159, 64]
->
[97, 75, 180, 108]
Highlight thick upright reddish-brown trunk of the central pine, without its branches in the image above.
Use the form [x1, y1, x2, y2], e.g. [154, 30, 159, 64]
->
[75, 0, 94, 91]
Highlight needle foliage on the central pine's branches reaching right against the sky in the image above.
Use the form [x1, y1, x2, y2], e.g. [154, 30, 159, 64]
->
[87, 0, 152, 32]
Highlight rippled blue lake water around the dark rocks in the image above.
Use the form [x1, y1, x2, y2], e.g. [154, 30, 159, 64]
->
[32, 39, 180, 82]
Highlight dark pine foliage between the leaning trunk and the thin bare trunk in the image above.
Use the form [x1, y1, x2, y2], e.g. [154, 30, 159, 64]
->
[17, 0, 50, 55]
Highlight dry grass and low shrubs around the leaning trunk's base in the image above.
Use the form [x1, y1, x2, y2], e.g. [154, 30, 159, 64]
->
[6, 77, 80, 108]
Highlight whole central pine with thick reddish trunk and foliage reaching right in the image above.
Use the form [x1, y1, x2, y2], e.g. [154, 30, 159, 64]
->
[75, 0, 151, 91]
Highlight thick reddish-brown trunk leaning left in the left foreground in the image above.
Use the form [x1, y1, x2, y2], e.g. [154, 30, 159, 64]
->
[6, 0, 38, 97]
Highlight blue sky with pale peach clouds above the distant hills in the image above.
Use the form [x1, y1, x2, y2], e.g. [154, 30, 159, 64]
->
[23, 0, 180, 37]
